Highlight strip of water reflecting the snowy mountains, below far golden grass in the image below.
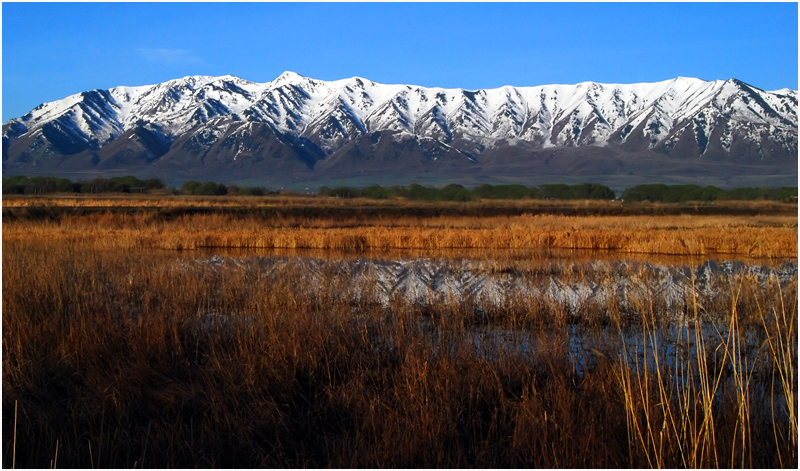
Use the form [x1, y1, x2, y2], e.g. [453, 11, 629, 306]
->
[187, 254, 797, 320]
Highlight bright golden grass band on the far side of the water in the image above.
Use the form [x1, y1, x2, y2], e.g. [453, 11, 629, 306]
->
[3, 198, 797, 257]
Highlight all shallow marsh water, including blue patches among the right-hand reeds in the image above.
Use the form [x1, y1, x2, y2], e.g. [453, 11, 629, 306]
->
[172, 251, 797, 424]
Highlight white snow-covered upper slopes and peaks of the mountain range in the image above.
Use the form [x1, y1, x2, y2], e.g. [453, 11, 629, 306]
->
[4, 71, 797, 163]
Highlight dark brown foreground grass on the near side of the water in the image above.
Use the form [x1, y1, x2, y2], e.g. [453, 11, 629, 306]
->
[2, 236, 797, 468]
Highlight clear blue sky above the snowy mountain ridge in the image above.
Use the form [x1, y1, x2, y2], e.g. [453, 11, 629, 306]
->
[2, 3, 798, 122]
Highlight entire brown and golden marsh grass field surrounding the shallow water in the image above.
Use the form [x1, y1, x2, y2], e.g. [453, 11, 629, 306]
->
[2, 197, 798, 468]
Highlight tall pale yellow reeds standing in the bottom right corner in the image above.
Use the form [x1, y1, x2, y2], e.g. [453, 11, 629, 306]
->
[616, 276, 797, 468]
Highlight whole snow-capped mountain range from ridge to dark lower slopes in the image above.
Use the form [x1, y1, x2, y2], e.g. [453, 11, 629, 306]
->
[3, 72, 798, 186]
